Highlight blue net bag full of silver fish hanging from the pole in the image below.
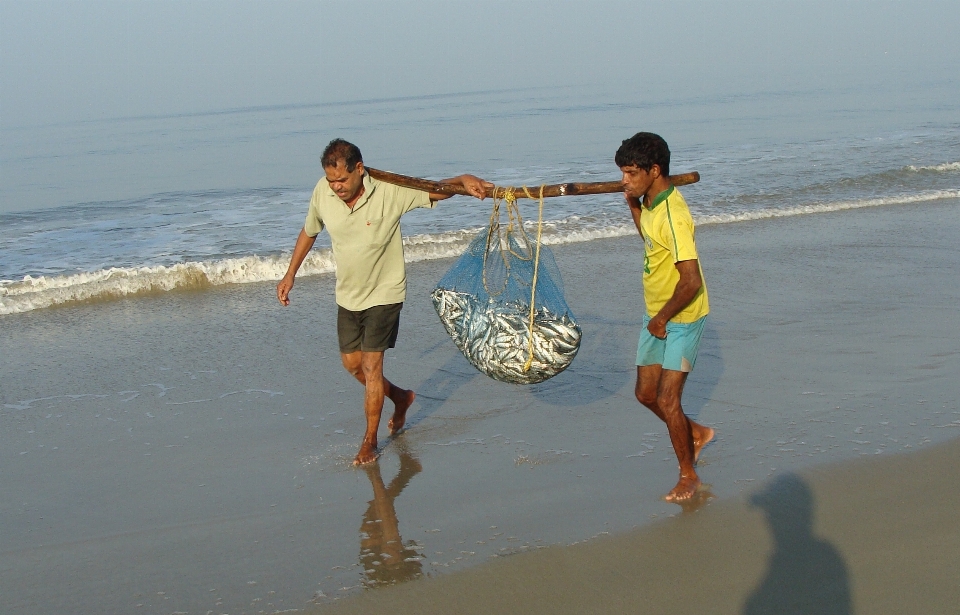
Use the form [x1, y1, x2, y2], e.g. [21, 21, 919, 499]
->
[431, 210, 581, 384]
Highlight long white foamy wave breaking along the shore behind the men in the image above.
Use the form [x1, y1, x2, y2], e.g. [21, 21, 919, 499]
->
[0, 189, 960, 315]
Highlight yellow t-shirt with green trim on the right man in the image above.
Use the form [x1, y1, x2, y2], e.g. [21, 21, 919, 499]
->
[640, 186, 710, 323]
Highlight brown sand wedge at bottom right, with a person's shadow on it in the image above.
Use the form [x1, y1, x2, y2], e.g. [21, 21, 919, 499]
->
[310, 440, 960, 615]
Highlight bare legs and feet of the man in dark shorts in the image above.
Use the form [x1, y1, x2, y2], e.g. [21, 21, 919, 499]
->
[340, 350, 416, 465]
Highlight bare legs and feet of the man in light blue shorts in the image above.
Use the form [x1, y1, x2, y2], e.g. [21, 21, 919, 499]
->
[636, 365, 713, 502]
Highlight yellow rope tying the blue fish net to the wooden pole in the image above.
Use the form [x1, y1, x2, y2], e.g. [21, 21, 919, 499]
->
[482, 184, 544, 372]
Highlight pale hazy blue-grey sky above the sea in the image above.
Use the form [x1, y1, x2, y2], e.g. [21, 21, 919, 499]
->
[0, 0, 960, 127]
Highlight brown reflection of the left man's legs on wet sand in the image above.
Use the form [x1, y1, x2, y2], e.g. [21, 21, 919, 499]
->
[360, 448, 423, 587]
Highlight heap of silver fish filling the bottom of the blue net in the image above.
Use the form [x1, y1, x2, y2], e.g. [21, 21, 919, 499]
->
[430, 288, 581, 384]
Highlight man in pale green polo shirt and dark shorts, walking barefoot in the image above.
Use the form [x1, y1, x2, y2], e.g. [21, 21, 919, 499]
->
[277, 139, 493, 465]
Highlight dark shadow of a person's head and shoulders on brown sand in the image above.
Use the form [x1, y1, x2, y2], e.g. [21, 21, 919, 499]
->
[743, 474, 852, 615]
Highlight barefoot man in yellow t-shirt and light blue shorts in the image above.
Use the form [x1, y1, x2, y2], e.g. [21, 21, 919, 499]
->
[615, 132, 714, 502]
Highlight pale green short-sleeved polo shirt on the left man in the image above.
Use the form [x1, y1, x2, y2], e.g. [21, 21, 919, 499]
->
[303, 175, 436, 312]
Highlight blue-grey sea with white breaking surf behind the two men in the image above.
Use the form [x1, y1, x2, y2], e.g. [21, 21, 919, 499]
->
[0, 75, 960, 315]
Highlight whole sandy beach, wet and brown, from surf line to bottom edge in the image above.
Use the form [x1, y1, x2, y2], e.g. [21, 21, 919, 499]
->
[0, 200, 960, 614]
